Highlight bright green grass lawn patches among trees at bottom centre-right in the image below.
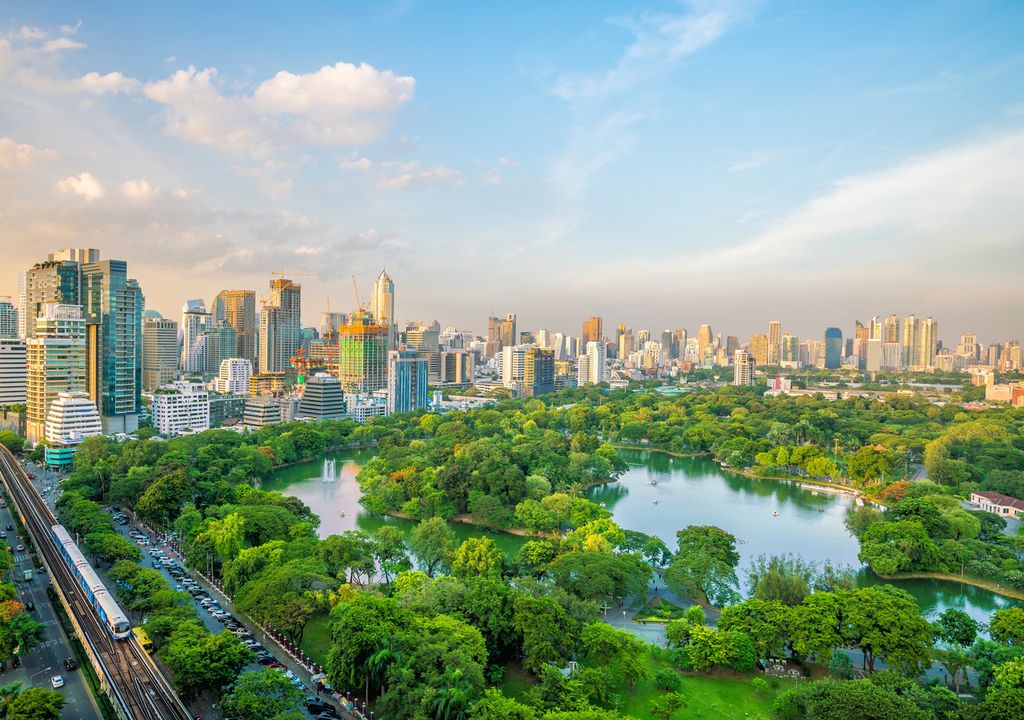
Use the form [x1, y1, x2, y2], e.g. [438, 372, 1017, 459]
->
[501, 659, 798, 720]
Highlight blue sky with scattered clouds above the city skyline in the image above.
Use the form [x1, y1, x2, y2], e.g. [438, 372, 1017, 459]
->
[0, 0, 1024, 344]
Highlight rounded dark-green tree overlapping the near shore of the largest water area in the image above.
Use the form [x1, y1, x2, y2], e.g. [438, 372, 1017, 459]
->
[665, 525, 739, 606]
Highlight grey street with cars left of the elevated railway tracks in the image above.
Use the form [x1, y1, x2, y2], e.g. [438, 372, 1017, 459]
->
[0, 495, 99, 720]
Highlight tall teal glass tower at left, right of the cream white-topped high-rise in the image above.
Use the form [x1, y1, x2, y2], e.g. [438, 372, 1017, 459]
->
[81, 260, 144, 434]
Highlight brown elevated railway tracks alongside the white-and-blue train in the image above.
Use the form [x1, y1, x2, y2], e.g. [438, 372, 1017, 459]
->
[0, 447, 194, 720]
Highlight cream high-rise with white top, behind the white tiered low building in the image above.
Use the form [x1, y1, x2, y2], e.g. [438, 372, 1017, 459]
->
[26, 302, 86, 442]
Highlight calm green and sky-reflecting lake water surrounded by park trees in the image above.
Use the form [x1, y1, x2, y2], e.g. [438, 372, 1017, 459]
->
[263, 450, 1016, 620]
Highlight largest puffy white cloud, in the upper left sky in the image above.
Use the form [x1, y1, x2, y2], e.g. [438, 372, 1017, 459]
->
[143, 62, 416, 159]
